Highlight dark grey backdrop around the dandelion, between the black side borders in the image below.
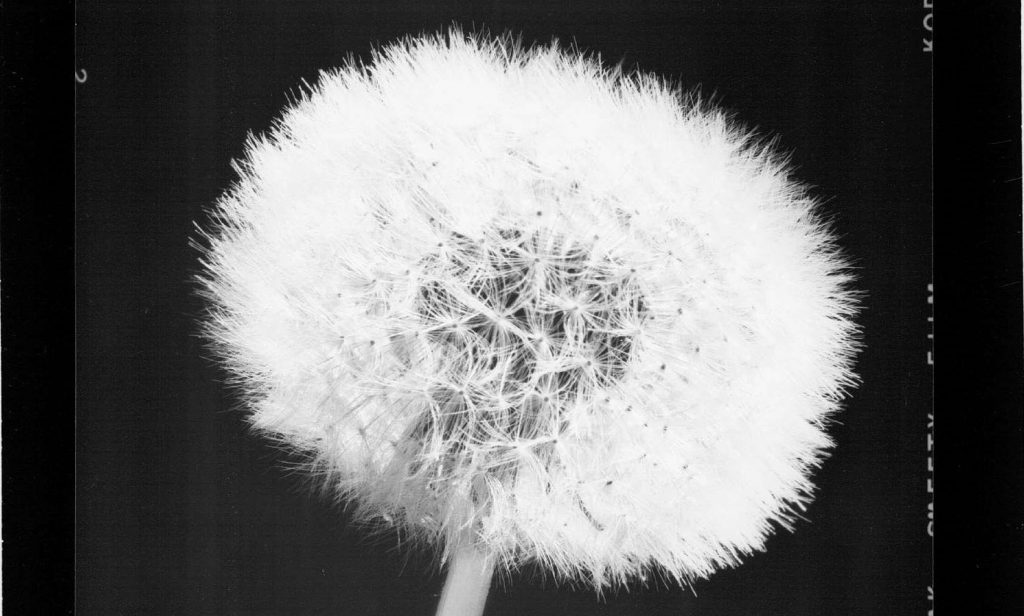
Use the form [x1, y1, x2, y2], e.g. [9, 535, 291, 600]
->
[68, 0, 932, 615]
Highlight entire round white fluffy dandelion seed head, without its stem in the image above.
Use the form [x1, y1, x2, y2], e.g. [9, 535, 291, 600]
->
[195, 32, 857, 590]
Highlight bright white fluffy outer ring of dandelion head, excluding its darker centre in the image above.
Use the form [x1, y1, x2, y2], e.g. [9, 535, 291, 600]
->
[193, 29, 860, 591]
